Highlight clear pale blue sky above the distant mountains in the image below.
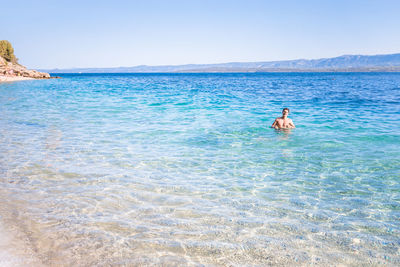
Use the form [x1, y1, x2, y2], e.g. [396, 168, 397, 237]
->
[0, 0, 400, 68]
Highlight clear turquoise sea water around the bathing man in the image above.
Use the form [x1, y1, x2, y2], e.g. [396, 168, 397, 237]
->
[0, 73, 400, 266]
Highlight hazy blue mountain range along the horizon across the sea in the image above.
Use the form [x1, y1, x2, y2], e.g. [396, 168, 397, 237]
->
[42, 53, 400, 73]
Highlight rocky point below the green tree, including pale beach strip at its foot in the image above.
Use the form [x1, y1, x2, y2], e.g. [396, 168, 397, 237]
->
[0, 56, 53, 82]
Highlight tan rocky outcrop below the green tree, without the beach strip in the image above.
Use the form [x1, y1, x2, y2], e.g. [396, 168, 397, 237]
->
[0, 56, 51, 79]
